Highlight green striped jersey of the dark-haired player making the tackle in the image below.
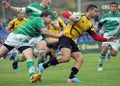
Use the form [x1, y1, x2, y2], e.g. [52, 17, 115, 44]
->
[13, 17, 47, 38]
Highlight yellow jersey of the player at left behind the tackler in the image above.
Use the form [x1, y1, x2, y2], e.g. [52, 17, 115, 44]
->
[8, 18, 27, 31]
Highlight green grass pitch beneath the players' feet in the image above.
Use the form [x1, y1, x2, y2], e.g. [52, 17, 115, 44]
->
[0, 54, 120, 86]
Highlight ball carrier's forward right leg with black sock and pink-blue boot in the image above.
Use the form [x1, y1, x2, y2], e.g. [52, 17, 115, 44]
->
[67, 44, 83, 83]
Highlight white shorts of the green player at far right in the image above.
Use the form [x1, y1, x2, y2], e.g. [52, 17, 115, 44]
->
[102, 34, 119, 51]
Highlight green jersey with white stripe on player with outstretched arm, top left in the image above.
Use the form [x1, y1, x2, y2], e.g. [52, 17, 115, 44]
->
[25, 3, 56, 21]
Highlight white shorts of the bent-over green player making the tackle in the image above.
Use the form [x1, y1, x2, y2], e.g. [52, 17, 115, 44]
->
[5, 33, 31, 49]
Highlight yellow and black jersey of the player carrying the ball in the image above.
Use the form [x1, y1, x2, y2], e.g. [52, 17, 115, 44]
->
[64, 13, 95, 41]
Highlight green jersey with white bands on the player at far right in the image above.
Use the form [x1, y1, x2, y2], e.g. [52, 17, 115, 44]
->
[100, 13, 120, 38]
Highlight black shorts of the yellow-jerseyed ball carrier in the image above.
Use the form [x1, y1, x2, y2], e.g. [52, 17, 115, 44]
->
[59, 36, 80, 52]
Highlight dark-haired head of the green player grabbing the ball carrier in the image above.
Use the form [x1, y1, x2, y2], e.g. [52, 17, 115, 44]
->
[40, 10, 52, 24]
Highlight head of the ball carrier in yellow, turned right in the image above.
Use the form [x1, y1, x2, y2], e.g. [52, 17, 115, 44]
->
[86, 5, 98, 18]
